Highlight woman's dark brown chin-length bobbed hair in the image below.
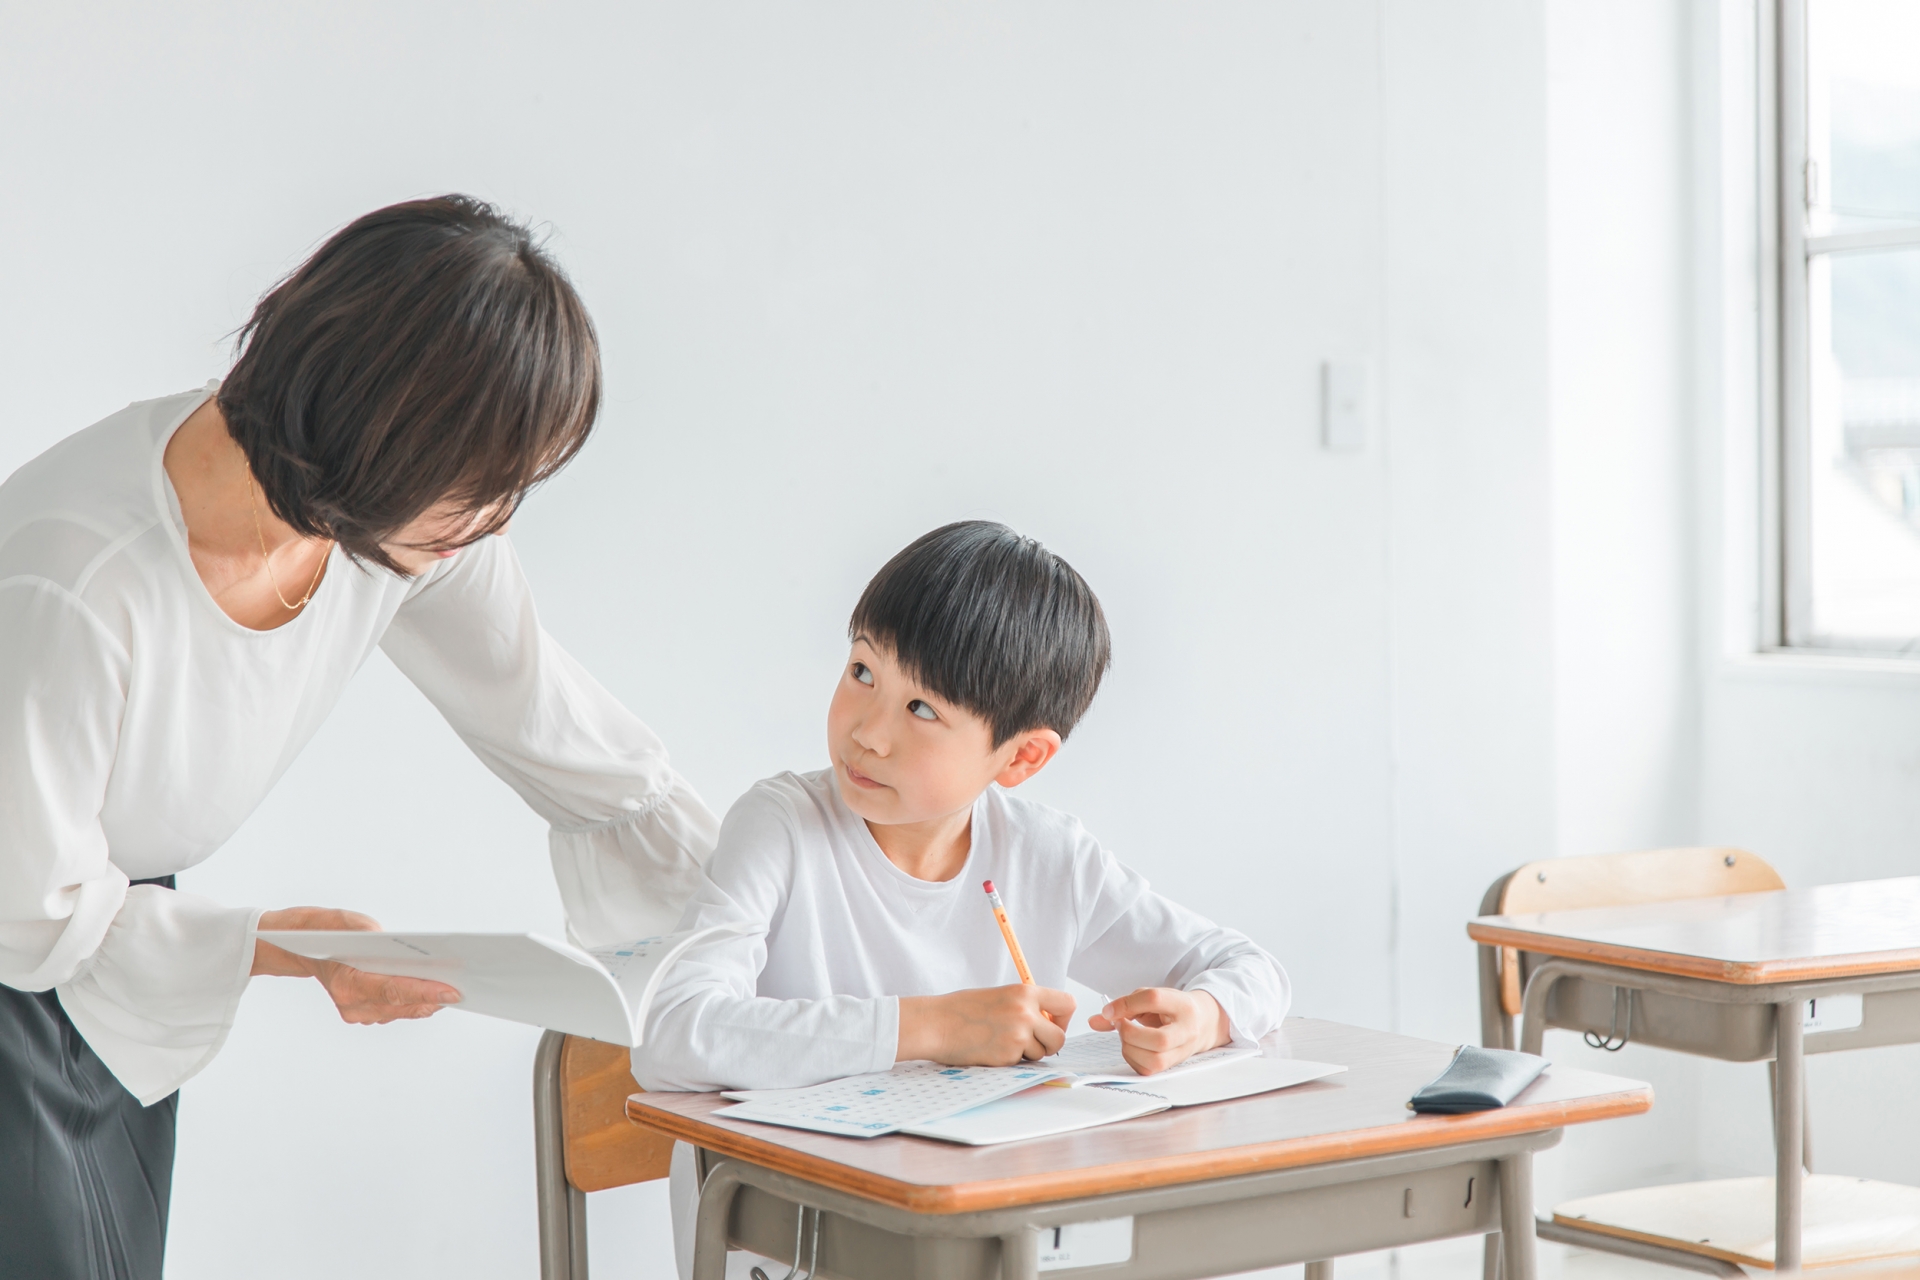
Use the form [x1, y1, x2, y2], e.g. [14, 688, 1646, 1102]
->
[219, 196, 601, 572]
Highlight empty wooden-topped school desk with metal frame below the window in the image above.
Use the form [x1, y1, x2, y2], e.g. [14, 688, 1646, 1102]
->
[1467, 877, 1920, 1274]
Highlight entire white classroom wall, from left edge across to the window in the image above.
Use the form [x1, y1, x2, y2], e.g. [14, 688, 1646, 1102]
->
[11, 0, 1920, 1280]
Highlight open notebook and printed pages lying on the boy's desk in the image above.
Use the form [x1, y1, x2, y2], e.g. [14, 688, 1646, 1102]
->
[714, 1031, 1346, 1146]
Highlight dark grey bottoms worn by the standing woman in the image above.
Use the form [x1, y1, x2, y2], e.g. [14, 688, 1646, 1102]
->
[0, 875, 180, 1280]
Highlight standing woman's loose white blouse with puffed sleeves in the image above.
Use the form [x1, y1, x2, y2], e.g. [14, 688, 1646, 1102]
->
[0, 384, 718, 1103]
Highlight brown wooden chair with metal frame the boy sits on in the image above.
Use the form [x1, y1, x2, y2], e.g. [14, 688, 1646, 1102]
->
[534, 1031, 674, 1280]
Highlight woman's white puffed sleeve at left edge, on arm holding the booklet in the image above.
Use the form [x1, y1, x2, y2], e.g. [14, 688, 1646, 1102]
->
[0, 578, 257, 1103]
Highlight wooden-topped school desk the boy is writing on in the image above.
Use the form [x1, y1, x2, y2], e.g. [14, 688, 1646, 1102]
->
[628, 1019, 1653, 1280]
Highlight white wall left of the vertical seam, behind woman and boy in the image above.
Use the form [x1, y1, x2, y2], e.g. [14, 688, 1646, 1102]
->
[0, 4, 1413, 1276]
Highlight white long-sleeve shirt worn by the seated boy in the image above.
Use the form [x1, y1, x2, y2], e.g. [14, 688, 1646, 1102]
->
[634, 770, 1288, 1090]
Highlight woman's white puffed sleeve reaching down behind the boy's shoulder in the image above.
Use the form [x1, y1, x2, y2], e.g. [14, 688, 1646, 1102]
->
[380, 537, 718, 946]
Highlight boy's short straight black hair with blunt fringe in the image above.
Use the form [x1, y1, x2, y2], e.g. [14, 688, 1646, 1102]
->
[847, 520, 1112, 748]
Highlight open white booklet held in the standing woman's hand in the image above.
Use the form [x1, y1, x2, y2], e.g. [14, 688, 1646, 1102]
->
[259, 925, 741, 1048]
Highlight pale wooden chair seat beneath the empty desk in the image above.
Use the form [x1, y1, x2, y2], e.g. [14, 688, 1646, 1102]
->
[1553, 1173, 1920, 1270]
